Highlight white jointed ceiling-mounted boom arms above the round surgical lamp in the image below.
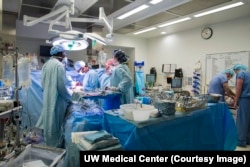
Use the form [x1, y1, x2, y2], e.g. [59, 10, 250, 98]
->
[23, 0, 113, 45]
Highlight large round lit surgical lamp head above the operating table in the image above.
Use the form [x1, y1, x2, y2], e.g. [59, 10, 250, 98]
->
[52, 38, 89, 51]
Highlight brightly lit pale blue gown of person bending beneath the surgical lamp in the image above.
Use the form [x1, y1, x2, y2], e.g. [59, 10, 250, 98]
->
[82, 69, 99, 91]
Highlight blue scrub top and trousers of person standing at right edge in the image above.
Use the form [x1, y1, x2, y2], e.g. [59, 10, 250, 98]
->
[236, 71, 250, 146]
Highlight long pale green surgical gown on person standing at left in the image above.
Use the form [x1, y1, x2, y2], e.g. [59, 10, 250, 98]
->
[36, 58, 71, 147]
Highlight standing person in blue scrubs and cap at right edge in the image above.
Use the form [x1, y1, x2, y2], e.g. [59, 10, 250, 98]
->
[233, 64, 250, 147]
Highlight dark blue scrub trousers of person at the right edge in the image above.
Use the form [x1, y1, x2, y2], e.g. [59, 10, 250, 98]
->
[236, 97, 250, 147]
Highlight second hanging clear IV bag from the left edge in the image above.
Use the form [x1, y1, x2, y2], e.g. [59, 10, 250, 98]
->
[17, 57, 31, 87]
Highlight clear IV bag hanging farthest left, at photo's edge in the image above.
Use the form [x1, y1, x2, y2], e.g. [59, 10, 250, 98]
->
[2, 55, 14, 87]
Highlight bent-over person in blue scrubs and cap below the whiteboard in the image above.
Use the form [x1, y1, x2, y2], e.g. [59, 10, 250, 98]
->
[208, 69, 235, 102]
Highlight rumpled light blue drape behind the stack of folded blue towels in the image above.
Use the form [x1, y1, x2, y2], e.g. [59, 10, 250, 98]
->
[64, 100, 104, 167]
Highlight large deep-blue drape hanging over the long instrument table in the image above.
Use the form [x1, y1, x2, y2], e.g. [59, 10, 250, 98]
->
[104, 103, 237, 151]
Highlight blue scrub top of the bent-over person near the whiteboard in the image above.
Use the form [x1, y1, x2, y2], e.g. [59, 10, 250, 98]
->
[208, 73, 228, 101]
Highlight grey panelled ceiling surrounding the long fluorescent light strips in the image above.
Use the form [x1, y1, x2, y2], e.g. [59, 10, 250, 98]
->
[0, 0, 250, 38]
